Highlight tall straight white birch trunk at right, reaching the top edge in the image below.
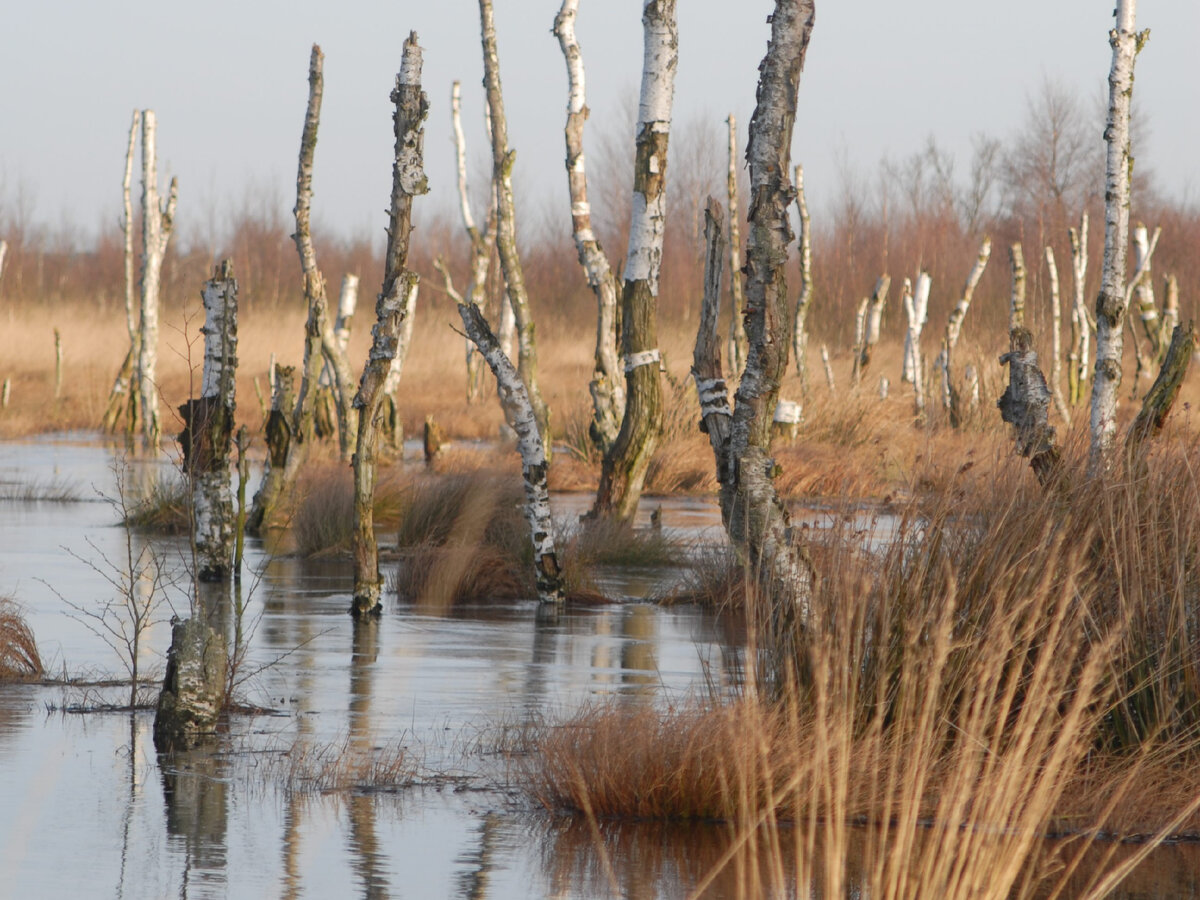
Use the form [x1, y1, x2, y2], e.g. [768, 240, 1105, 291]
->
[1088, 0, 1150, 475]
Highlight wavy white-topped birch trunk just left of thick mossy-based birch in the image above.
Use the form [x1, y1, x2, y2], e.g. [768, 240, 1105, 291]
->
[554, 0, 625, 454]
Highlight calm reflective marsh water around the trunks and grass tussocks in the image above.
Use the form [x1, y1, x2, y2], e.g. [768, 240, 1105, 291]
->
[0, 436, 1200, 899]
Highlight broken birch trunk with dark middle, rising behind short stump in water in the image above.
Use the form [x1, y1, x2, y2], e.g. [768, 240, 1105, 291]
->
[179, 259, 238, 581]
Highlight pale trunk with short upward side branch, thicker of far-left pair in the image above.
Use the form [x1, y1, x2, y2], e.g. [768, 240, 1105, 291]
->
[136, 109, 179, 450]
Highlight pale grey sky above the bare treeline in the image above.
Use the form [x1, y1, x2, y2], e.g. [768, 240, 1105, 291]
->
[0, 0, 1200, 240]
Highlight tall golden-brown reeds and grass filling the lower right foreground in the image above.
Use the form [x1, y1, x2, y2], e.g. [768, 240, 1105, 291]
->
[526, 444, 1200, 898]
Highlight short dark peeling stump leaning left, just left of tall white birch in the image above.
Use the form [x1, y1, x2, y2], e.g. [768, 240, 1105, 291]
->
[996, 328, 1061, 486]
